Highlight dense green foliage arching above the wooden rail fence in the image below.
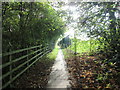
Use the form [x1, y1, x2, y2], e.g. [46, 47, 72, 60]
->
[2, 2, 65, 52]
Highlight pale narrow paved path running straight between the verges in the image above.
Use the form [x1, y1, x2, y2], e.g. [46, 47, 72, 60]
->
[47, 49, 70, 88]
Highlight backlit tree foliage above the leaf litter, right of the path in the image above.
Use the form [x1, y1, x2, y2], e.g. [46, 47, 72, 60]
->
[78, 2, 120, 56]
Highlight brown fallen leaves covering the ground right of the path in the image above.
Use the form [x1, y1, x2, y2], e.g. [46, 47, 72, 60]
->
[66, 54, 120, 90]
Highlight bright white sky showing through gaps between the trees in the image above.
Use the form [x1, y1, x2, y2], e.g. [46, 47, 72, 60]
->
[50, 0, 120, 40]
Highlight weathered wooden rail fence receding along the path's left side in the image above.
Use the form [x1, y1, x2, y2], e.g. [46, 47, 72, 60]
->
[0, 45, 51, 89]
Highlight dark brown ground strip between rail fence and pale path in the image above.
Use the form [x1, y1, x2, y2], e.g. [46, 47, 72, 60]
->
[14, 59, 54, 88]
